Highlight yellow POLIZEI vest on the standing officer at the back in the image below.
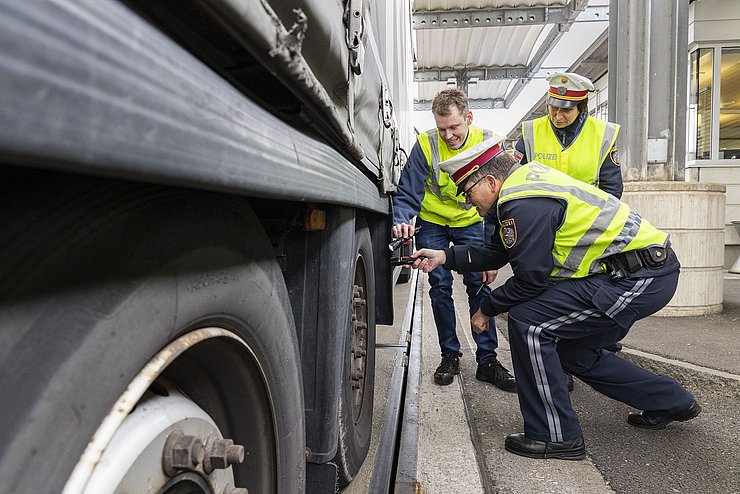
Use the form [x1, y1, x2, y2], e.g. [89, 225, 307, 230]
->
[522, 115, 619, 186]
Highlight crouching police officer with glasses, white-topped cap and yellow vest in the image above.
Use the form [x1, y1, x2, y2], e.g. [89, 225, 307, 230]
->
[413, 140, 701, 460]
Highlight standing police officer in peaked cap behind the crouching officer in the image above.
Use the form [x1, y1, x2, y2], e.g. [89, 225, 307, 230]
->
[514, 72, 623, 199]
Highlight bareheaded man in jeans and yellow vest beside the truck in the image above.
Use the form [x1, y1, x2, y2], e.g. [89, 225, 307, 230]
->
[392, 89, 516, 391]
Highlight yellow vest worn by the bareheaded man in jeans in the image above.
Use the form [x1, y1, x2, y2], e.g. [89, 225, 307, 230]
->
[417, 126, 493, 227]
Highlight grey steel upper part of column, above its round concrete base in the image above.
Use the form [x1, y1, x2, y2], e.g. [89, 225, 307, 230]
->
[609, 0, 689, 182]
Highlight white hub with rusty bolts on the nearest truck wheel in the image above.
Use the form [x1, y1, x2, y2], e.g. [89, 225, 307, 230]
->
[69, 376, 244, 494]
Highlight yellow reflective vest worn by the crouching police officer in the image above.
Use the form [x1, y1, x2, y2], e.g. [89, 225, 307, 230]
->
[498, 161, 668, 280]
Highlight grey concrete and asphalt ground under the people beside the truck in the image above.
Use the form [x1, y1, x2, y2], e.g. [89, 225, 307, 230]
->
[343, 272, 740, 494]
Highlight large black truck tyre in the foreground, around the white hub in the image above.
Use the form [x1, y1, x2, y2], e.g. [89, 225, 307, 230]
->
[0, 169, 305, 493]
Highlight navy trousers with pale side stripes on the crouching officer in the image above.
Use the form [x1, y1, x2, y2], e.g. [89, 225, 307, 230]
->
[509, 270, 694, 441]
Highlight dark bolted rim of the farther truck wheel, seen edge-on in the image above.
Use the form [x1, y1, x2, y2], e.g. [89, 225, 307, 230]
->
[334, 221, 375, 485]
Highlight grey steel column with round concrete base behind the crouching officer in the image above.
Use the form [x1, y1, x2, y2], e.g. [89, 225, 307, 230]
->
[609, 0, 724, 315]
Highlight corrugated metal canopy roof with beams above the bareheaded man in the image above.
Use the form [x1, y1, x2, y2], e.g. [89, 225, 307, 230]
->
[412, 0, 608, 110]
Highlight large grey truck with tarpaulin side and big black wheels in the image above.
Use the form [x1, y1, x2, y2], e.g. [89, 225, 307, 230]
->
[0, 0, 413, 494]
